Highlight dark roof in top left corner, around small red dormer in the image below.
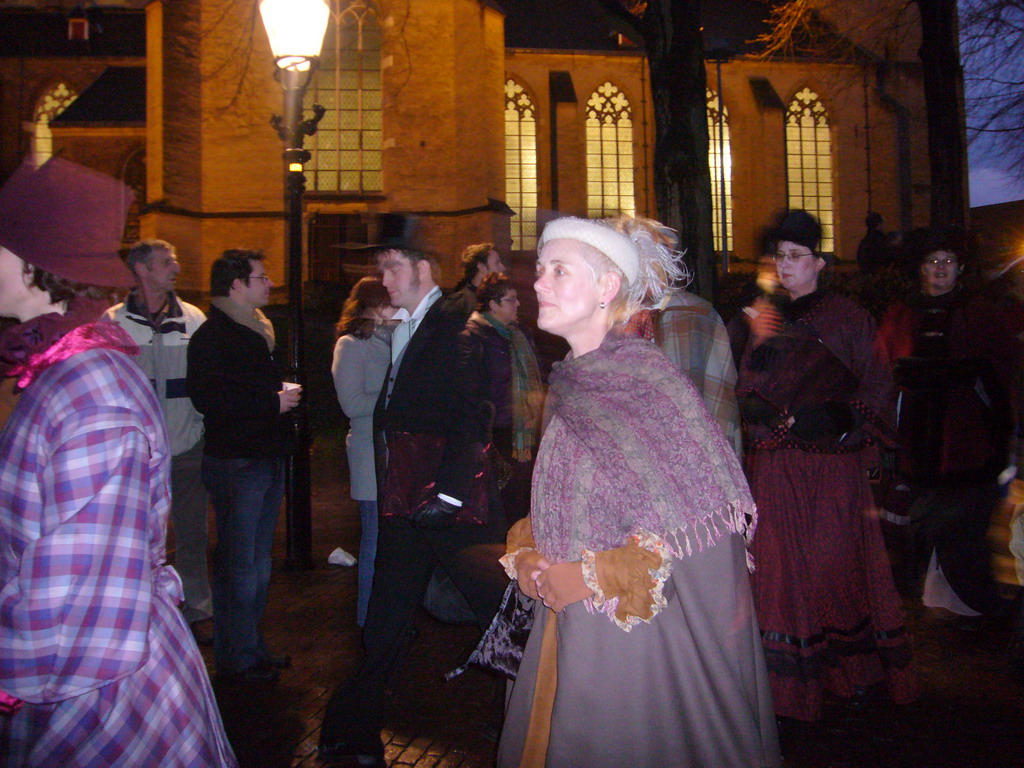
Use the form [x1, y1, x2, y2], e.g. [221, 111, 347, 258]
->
[0, 8, 145, 58]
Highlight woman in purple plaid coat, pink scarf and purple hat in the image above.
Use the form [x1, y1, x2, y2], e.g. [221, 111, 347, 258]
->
[0, 159, 237, 768]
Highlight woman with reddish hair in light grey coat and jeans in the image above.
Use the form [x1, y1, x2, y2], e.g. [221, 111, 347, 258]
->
[331, 278, 395, 627]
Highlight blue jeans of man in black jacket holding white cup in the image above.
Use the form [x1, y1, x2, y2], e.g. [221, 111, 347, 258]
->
[203, 456, 285, 674]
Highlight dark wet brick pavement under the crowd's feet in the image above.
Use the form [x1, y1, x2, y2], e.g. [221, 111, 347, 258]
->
[186, 434, 1024, 768]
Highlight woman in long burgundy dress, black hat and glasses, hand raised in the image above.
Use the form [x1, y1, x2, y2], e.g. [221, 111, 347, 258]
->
[736, 211, 918, 721]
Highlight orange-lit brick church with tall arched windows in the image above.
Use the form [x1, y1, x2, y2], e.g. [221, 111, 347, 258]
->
[0, 0, 942, 292]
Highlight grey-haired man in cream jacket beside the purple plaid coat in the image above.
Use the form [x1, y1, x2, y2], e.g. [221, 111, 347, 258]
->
[106, 240, 213, 645]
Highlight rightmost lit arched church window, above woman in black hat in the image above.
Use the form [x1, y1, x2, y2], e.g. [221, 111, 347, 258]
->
[785, 88, 836, 253]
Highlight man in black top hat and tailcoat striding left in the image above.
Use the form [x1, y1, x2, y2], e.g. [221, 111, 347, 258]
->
[321, 225, 507, 766]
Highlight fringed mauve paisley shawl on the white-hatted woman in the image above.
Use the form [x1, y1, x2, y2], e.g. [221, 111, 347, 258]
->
[531, 333, 756, 561]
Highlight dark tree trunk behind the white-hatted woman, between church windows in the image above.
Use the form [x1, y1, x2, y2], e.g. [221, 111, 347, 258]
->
[640, 0, 717, 301]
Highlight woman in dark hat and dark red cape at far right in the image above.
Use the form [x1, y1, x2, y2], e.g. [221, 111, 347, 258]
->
[878, 228, 1018, 616]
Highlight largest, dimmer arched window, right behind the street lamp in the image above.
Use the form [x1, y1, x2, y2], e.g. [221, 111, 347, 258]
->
[305, 0, 383, 194]
